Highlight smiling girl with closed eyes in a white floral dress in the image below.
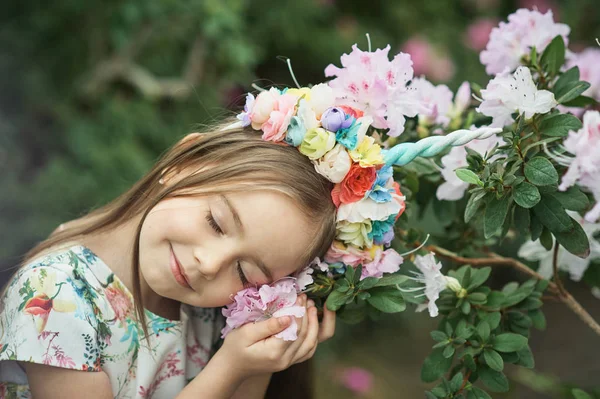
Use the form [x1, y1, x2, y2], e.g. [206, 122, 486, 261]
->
[0, 124, 335, 399]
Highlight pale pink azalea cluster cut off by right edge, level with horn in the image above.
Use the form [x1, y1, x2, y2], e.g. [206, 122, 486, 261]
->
[557, 111, 600, 222]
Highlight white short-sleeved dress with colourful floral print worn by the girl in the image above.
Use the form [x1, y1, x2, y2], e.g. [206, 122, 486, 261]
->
[0, 245, 223, 399]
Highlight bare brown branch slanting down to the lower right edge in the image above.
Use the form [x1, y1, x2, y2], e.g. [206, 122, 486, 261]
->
[426, 245, 600, 336]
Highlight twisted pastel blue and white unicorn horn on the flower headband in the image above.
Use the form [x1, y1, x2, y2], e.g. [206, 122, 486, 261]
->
[383, 127, 502, 166]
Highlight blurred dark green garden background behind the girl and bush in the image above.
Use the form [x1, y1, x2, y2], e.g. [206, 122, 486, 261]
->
[0, 0, 600, 398]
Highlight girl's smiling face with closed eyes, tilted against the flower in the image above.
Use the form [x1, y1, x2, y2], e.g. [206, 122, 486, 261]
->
[140, 191, 314, 307]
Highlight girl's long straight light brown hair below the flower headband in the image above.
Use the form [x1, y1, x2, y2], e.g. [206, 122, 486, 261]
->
[23, 121, 335, 336]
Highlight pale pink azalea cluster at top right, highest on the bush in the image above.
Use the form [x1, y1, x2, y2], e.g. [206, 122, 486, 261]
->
[479, 8, 571, 75]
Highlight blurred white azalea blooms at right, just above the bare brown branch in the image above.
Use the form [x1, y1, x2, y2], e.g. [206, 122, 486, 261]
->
[517, 211, 600, 281]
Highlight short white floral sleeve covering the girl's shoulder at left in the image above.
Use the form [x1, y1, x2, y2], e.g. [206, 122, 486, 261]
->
[0, 245, 122, 377]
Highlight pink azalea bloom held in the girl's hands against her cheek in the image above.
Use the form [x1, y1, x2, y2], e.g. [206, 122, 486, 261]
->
[221, 278, 306, 341]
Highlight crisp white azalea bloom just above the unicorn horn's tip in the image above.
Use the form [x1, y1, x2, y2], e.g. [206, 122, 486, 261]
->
[477, 66, 558, 127]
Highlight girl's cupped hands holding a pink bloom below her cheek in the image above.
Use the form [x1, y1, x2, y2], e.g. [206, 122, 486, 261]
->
[214, 294, 322, 380]
